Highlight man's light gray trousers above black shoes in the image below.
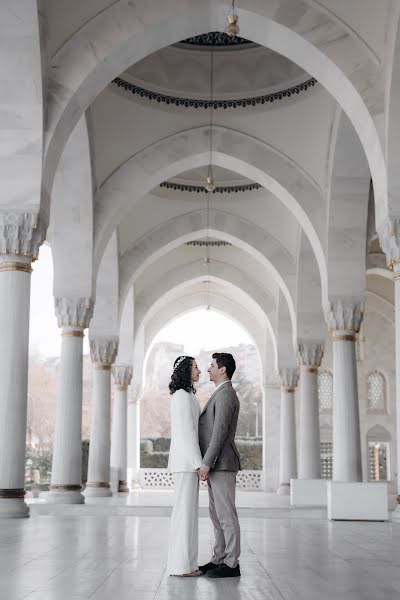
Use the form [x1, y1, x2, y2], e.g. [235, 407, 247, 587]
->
[207, 471, 240, 567]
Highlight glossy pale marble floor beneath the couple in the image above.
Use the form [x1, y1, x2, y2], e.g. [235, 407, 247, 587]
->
[0, 515, 400, 600]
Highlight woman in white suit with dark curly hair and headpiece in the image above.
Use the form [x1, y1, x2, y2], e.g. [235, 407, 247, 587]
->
[167, 356, 202, 577]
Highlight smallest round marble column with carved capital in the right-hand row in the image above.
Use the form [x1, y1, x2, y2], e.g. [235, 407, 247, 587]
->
[277, 369, 299, 495]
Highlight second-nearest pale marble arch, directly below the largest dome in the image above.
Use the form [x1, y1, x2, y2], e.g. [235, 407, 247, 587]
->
[95, 127, 327, 310]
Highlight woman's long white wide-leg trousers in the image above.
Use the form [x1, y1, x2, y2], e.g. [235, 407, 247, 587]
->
[167, 472, 199, 575]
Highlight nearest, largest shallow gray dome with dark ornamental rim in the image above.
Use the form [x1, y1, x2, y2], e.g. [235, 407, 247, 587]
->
[114, 32, 315, 108]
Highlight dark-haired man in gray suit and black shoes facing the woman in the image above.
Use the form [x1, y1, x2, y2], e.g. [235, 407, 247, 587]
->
[199, 352, 240, 578]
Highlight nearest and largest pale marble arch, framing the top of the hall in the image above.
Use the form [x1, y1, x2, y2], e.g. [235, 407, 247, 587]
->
[43, 0, 387, 230]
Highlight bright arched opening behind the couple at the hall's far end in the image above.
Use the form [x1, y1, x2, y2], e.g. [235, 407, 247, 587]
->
[140, 308, 263, 486]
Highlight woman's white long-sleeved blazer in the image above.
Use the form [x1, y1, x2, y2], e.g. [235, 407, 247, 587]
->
[168, 390, 202, 473]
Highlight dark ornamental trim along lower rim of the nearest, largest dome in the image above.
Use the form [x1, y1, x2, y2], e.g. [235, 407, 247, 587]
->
[112, 77, 317, 109]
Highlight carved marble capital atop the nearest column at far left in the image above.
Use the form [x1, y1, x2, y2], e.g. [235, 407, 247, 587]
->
[0, 210, 46, 260]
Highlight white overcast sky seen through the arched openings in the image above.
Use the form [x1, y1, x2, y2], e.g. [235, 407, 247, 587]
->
[30, 245, 251, 357]
